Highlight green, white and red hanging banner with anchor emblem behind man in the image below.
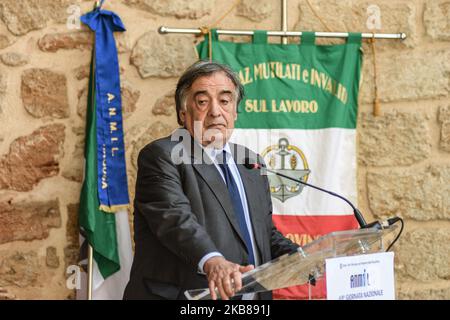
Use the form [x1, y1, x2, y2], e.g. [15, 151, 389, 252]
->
[198, 30, 362, 299]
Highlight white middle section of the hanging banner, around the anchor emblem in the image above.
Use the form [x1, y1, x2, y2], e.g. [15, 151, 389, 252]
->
[231, 128, 357, 216]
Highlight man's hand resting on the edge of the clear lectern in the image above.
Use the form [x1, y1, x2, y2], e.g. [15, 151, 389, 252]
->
[203, 257, 254, 300]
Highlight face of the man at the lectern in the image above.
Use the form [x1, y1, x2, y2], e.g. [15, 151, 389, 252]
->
[180, 72, 237, 148]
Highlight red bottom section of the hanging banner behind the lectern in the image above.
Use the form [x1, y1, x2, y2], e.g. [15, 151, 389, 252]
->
[272, 214, 358, 299]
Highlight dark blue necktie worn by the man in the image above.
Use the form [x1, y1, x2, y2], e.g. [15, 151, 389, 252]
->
[217, 151, 255, 265]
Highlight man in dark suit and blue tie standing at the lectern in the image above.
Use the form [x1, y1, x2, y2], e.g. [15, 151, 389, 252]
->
[124, 61, 298, 299]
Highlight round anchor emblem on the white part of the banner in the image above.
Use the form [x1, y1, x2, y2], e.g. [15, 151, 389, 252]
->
[261, 138, 311, 202]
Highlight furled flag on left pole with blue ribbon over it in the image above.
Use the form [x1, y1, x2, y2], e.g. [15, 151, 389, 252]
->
[79, 4, 132, 300]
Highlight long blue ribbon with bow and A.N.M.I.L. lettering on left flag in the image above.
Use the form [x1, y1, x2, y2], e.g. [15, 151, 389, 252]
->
[81, 8, 129, 212]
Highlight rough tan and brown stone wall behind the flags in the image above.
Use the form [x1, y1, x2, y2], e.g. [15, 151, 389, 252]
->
[0, 0, 450, 299]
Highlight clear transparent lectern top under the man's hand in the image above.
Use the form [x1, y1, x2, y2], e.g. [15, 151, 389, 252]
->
[185, 226, 396, 300]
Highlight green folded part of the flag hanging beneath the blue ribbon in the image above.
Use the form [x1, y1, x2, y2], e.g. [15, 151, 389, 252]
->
[78, 53, 120, 279]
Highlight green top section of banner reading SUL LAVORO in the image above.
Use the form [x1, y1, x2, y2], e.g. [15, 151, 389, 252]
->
[198, 33, 362, 129]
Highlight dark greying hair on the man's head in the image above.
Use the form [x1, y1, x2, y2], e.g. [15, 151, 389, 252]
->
[175, 60, 244, 125]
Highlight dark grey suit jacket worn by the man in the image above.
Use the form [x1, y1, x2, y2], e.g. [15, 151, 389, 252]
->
[124, 129, 298, 299]
